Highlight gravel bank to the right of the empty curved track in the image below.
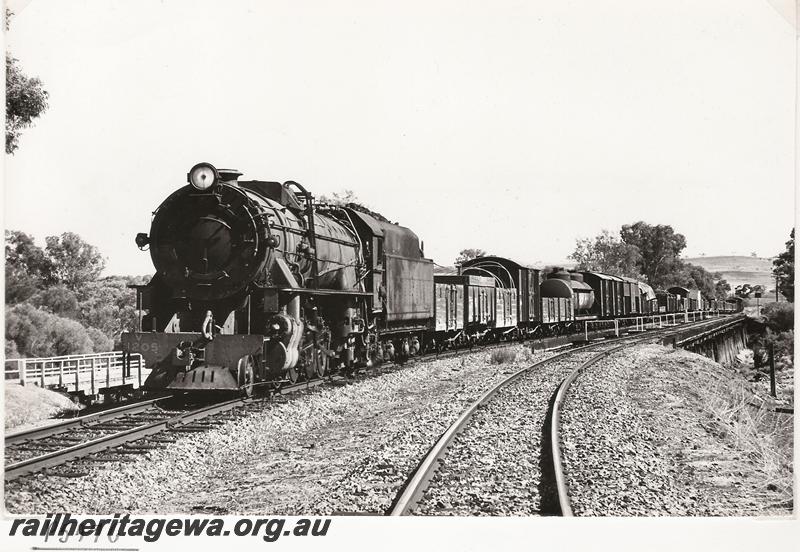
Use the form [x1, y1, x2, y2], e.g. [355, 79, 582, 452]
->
[562, 345, 792, 516]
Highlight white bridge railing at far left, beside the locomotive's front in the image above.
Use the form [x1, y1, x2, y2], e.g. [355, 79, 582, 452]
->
[5, 351, 150, 395]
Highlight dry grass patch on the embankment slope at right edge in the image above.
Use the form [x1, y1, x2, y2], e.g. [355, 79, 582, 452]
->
[705, 380, 794, 501]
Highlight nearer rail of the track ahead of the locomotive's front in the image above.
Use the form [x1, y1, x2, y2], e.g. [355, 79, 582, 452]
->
[5, 399, 254, 480]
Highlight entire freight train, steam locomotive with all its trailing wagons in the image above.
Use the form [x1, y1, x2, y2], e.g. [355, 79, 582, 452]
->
[122, 163, 733, 395]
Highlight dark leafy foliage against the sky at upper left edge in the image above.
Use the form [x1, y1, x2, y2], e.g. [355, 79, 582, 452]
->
[6, 9, 48, 154]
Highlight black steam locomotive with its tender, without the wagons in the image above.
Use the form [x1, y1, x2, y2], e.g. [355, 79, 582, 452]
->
[122, 163, 432, 394]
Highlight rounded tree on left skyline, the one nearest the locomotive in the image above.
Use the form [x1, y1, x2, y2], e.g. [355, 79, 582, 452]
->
[45, 232, 106, 291]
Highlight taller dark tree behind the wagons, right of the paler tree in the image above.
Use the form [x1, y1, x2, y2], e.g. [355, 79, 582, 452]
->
[620, 221, 686, 288]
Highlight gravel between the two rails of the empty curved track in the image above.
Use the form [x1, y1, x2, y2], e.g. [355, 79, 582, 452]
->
[412, 351, 608, 516]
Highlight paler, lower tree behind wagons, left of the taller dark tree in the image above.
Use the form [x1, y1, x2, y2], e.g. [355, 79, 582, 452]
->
[569, 230, 641, 278]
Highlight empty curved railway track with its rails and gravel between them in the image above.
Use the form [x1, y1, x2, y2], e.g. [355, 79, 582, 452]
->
[387, 321, 732, 516]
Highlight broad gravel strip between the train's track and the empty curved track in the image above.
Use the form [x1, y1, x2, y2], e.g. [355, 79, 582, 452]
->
[6, 346, 552, 515]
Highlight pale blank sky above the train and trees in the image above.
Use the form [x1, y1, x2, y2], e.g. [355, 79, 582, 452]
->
[5, 0, 797, 274]
